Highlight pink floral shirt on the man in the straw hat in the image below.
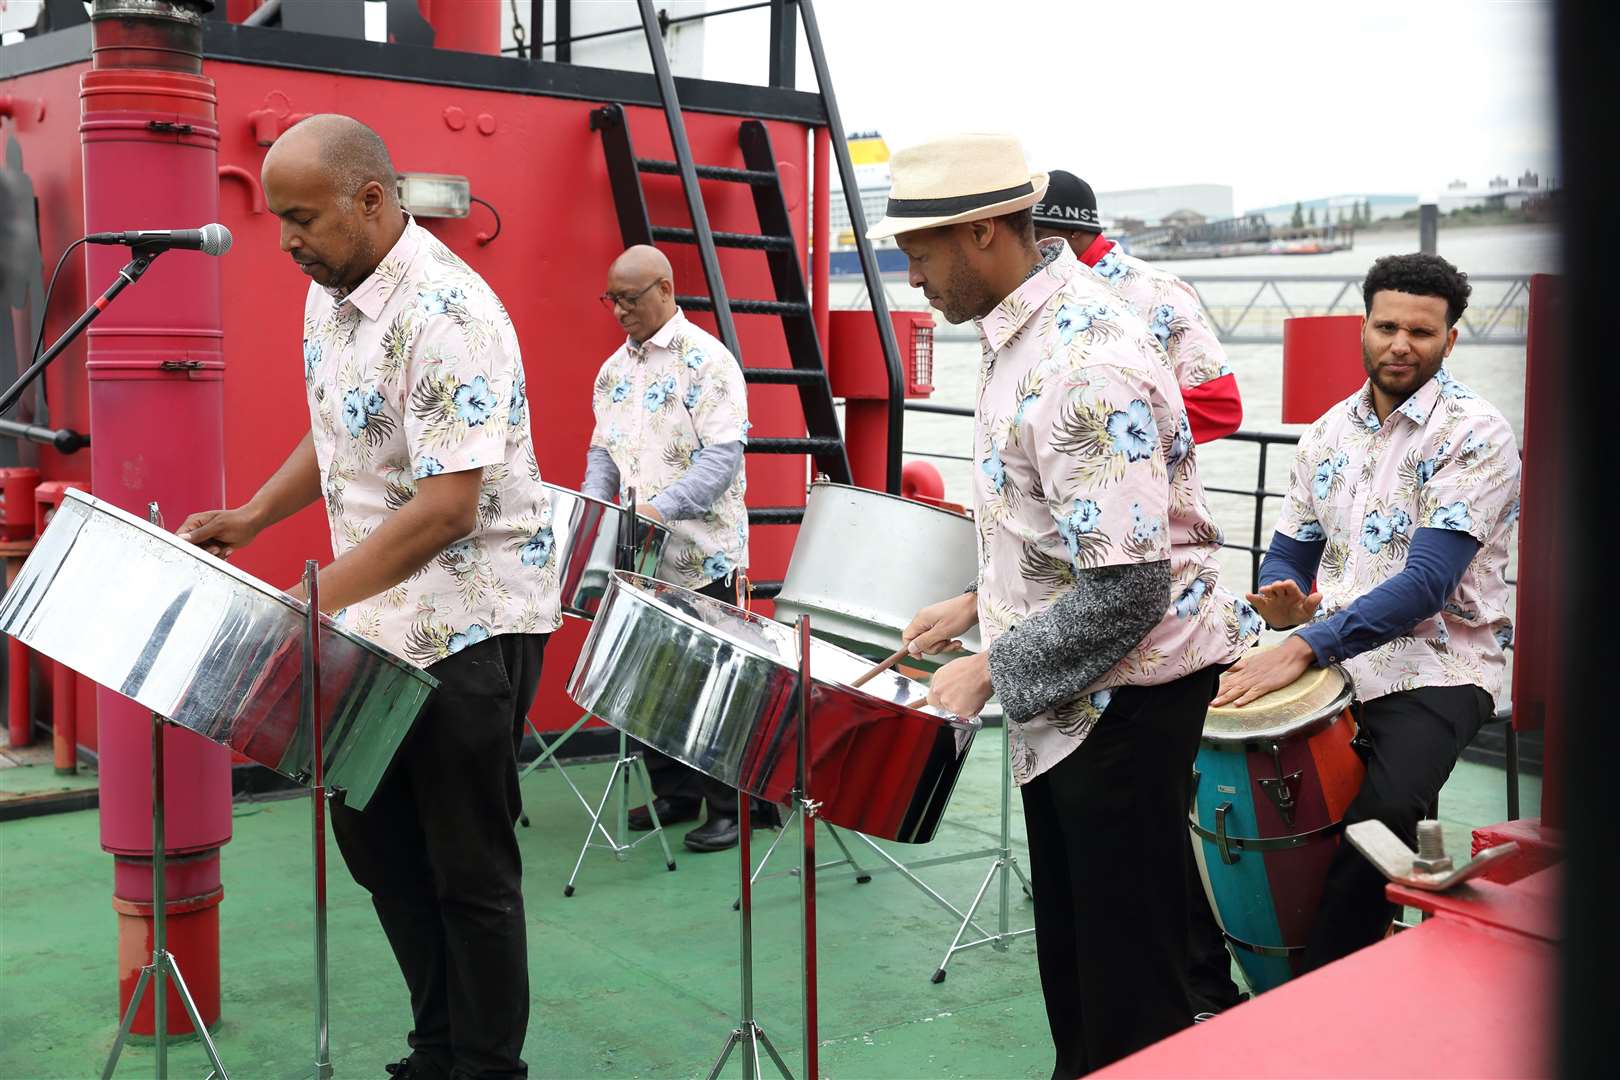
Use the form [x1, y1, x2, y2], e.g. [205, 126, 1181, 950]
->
[974, 240, 1260, 784]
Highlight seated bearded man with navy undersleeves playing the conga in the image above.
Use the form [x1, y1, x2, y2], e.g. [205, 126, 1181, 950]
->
[1215, 254, 1520, 970]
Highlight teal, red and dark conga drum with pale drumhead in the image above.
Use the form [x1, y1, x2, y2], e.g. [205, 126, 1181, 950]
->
[1187, 654, 1364, 991]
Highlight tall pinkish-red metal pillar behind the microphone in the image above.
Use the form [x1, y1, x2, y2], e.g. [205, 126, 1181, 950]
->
[79, 0, 230, 1035]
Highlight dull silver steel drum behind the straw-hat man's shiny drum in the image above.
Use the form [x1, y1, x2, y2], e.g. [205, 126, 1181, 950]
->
[776, 481, 982, 660]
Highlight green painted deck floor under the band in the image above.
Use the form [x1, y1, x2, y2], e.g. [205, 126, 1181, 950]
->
[0, 730, 1541, 1080]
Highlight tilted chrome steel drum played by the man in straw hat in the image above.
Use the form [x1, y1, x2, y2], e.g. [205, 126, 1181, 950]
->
[569, 573, 980, 844]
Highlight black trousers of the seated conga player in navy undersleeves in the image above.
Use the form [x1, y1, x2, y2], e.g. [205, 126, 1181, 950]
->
[1304, 687, 1492, 972]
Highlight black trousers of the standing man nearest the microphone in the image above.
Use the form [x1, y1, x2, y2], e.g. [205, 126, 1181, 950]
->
[332, 633, 546, 1078]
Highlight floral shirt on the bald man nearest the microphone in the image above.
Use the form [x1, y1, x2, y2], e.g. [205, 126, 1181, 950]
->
[303, 220, 562, 667]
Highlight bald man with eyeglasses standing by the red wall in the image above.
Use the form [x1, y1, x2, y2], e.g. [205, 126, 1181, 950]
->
[582, 244, 771, 852]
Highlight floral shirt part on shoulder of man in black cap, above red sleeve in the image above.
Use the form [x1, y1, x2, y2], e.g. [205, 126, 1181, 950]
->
[1082, 236, 1231, 390]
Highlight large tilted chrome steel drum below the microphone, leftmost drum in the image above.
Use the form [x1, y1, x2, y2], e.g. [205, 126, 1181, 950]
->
[0, 491, 439, 810]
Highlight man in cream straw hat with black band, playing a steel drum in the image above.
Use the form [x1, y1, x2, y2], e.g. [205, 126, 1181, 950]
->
[887, 134, 1260, 1077]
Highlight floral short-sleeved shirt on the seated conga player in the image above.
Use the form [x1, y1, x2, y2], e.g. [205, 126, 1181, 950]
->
[1277, 368, 1520, 701]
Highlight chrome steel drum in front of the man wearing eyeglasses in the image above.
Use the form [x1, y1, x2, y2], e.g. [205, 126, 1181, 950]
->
[541, 483, 669, 619]
